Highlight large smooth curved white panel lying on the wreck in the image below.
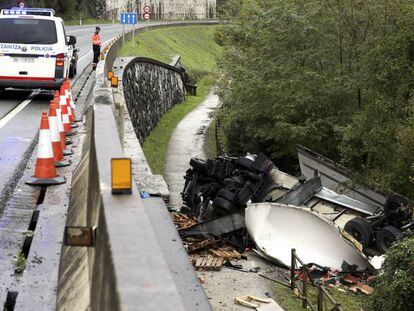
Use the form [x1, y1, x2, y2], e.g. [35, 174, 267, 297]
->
[245, 203, 370, 270]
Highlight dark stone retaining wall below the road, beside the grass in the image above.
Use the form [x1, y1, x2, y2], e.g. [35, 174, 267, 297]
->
[122, 57, 186, 143]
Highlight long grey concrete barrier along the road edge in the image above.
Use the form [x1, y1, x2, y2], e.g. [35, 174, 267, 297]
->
[57, 23, 215, 310]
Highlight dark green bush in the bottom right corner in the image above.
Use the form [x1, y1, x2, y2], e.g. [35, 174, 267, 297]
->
[370, 238, 414, 311]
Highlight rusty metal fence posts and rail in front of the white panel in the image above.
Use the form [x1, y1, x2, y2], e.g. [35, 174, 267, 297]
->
[290, 249, 343, 311]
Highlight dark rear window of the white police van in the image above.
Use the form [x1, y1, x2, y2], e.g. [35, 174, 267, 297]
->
[0, 18, 57, 44]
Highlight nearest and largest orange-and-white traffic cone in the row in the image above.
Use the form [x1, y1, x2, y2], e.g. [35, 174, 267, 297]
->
[26, 112, 66, 186]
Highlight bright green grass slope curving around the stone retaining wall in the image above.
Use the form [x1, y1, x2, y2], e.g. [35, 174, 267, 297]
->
[119, 26, 221, 174]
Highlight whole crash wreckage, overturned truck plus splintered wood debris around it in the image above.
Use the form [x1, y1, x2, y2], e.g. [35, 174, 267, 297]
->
[172, 150, 414, 310]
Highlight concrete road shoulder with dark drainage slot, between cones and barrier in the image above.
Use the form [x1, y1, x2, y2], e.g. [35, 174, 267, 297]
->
[0, 66, 93, 310]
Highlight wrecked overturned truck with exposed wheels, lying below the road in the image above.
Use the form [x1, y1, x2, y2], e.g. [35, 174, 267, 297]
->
[182, 147, 413, 269]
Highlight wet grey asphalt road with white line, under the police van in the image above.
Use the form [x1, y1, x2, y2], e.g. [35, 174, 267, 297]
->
[0, 25, 133, 216]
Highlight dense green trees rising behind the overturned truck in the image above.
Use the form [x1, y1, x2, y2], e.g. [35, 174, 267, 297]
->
[219, 0, 414, 199]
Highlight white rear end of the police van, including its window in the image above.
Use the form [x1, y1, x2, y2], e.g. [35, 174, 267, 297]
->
[0, 16, 58, 82]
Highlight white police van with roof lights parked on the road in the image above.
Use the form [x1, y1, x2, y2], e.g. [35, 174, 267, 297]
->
[0, 8, 79, 90]
